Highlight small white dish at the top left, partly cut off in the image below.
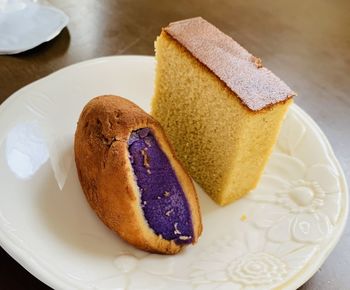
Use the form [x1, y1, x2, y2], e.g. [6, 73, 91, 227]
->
[0, 0, 68, 54]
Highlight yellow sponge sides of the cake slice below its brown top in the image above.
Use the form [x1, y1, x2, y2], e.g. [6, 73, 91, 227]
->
[151, 26, 292, 205]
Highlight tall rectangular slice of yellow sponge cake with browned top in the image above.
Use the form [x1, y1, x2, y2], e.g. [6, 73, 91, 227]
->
[151, 17, 295, 205]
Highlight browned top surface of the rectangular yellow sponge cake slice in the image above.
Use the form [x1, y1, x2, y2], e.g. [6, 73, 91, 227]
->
[164, 17, 295, 111]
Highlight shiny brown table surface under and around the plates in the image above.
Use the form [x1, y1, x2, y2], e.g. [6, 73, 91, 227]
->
[0, 0, 350, 290]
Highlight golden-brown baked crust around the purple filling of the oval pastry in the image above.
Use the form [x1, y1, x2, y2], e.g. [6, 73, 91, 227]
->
[74, 96, 202, 254]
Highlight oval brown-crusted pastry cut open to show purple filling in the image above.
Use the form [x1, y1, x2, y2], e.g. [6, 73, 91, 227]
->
[74, 96, 202, 254]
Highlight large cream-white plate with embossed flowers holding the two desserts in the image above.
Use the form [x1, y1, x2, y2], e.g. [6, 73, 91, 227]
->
[0, 56, 348, 290]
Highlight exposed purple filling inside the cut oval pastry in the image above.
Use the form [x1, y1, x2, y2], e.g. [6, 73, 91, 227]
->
[128, 128, 193, 244]
